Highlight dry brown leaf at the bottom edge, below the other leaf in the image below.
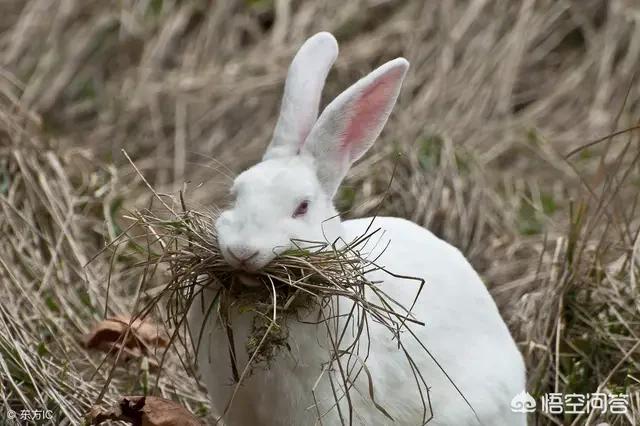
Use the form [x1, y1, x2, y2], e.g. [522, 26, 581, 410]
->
[87, 396, 203, 426]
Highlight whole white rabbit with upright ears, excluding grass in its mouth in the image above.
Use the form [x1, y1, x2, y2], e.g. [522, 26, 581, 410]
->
[189, 32, 526, 426]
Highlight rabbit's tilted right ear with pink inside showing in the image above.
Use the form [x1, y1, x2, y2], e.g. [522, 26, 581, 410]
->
[303, 58, 409, 195]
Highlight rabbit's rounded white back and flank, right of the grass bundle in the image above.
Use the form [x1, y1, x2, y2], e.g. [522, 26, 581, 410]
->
[343, 217, 526, 426]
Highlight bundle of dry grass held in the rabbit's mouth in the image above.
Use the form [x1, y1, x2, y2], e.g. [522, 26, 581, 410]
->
[114, 193, 426, 396]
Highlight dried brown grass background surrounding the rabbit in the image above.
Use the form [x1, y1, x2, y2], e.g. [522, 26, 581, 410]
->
[0, 0, 640, 424]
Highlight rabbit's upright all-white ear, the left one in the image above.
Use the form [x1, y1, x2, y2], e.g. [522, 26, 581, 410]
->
[263, 32, 338, 160]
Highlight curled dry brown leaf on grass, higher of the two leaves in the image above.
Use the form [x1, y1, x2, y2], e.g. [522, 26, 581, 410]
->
[85, 316, 169, 360]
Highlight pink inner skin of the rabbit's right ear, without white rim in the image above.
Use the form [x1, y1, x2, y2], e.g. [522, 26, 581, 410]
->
[340, 69, 404, 160]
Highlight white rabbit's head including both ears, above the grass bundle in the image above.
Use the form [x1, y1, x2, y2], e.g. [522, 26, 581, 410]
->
[216, 32, 409, 272]
